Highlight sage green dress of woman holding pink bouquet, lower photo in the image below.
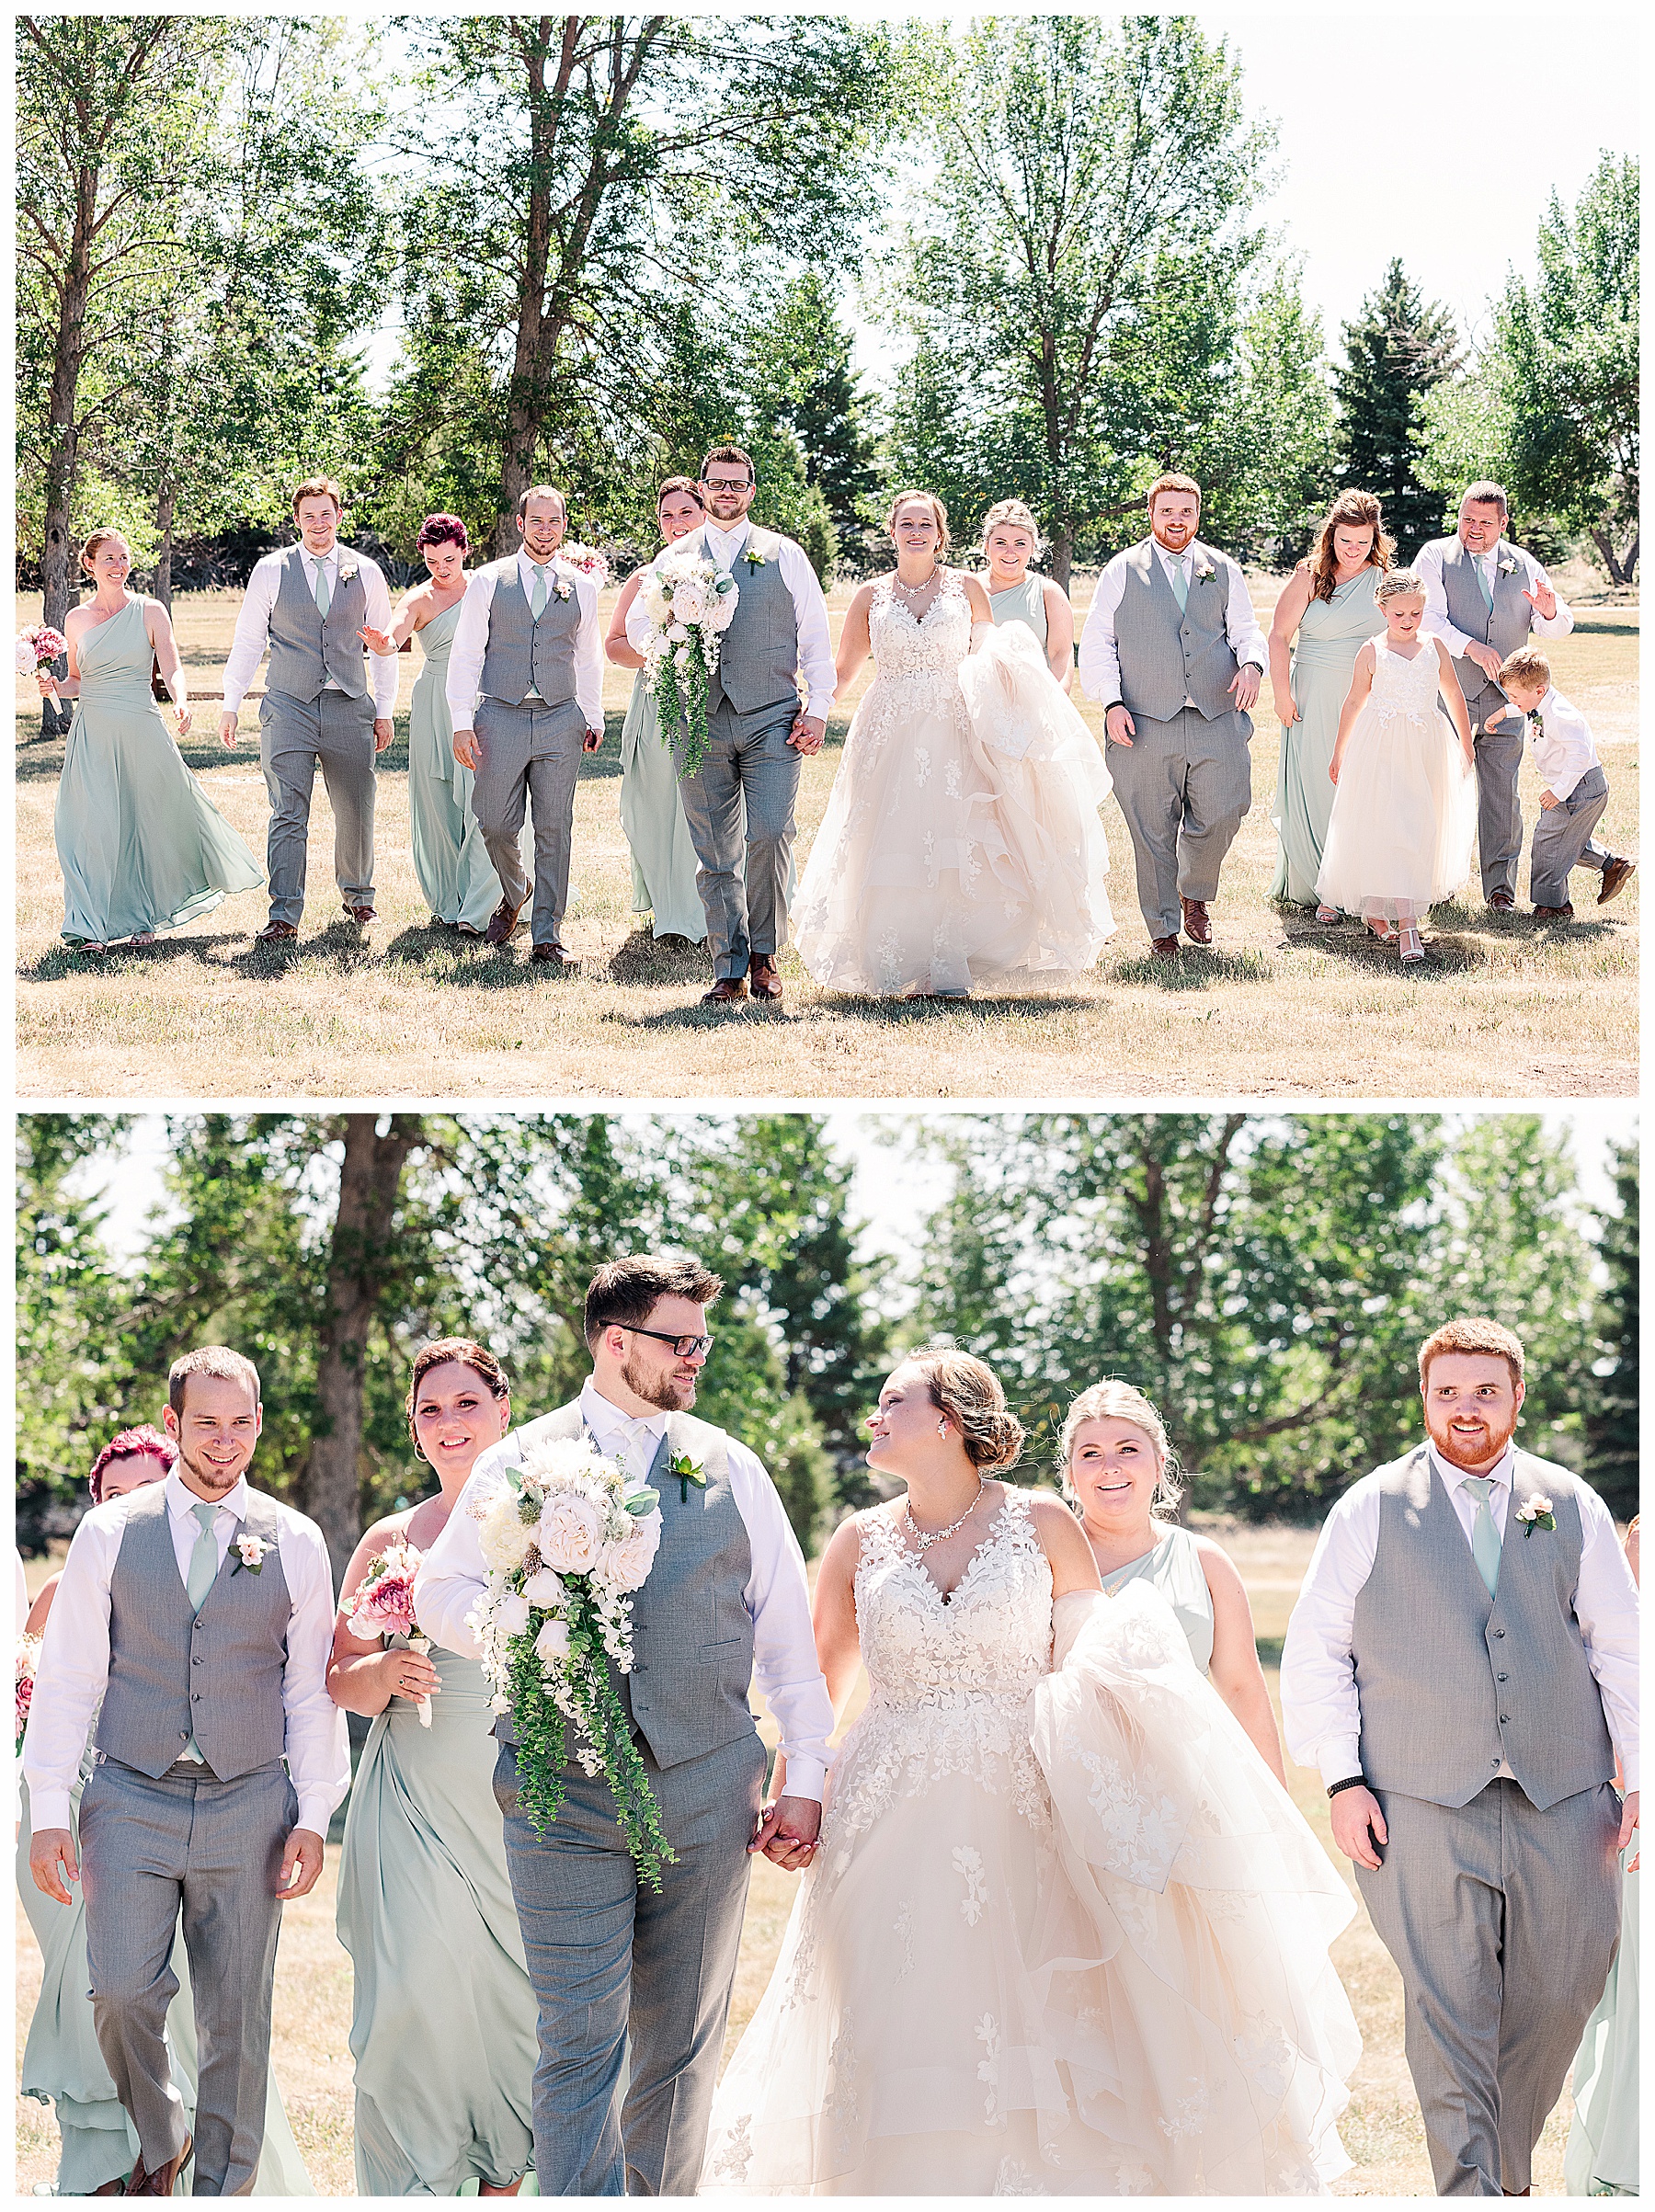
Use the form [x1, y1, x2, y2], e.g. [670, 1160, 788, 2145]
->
[338, 1648, 535, 2196]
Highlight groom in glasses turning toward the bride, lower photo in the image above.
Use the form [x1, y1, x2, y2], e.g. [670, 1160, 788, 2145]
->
[416, 1257, 834, 2196]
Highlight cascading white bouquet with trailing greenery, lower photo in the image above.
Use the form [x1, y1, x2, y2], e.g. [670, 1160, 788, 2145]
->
[467, 1435, 675, 1889]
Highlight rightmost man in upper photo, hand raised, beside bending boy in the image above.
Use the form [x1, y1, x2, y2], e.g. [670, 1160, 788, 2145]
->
[1414, 485, 1575, 914]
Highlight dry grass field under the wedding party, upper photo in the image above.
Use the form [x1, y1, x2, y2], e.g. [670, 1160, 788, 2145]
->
[17, 571, 1639, 1100]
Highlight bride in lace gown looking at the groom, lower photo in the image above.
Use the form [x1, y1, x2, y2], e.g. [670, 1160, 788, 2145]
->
[702, 1347, 1361, 2196]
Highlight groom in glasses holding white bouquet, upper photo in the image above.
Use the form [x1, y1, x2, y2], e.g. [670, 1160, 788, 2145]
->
[626, 445, 834, 1007]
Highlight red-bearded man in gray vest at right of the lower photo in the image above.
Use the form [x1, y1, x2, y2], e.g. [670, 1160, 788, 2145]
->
[1281, 1318, 1638, 2196]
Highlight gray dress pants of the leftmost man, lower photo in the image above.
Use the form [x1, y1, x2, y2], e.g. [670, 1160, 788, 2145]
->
[80, 1759, 299, 2196]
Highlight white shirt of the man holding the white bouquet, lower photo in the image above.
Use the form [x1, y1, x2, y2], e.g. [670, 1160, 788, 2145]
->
[414, 1376, 834, 1798]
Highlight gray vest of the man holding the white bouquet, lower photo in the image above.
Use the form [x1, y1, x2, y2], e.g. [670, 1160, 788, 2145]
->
[494, 1400, 755, 1767]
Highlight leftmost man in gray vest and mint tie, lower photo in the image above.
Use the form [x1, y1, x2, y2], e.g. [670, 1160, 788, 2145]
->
[24, 1345, 349, 2196]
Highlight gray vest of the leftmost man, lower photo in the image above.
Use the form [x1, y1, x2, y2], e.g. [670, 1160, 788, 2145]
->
[95, 1482, 292, 1783]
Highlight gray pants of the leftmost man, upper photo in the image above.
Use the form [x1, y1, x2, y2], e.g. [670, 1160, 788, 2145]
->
[259, 690, 374, 927]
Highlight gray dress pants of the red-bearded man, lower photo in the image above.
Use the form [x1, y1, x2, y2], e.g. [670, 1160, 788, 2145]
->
[1356, 1781, 1619, 2196]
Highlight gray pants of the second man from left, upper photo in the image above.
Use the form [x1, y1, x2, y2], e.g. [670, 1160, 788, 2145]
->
[472, 699, 587, 944]
